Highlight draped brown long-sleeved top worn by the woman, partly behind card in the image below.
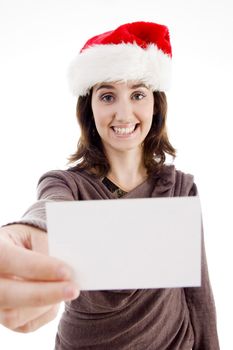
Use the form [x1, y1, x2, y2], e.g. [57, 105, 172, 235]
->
[20, 166, 219, 350]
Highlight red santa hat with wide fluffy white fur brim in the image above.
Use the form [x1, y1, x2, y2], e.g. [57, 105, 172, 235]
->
[68, 22, 172, 97]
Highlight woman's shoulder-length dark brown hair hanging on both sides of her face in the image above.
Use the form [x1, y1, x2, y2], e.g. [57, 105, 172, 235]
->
[69, 90, 176, 177]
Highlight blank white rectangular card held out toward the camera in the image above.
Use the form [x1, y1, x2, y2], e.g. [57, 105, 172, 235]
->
[46, 197, 201, 290]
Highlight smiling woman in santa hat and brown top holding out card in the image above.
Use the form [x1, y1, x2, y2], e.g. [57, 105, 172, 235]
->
[0, 22, 219, 350]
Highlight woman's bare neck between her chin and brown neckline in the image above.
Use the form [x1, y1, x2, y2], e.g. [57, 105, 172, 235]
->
[107, 151, 147, 192]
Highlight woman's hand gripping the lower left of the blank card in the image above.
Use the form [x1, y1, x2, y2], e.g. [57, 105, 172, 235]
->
[0, 224, 79, 332]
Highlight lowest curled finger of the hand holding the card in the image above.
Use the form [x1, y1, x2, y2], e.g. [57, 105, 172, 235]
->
[14, 307, 57, 333]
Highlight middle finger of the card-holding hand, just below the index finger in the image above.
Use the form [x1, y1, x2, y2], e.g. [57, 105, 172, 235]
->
[0, 304, 59, 330]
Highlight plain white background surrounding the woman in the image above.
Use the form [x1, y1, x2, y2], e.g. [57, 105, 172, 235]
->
[0, 0, 233, 350]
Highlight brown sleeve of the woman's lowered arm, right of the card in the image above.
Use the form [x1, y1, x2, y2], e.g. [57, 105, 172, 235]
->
[184, 184, 220, 350]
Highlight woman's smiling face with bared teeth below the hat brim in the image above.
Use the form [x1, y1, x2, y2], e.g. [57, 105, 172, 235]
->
[92, 81, 154, 155]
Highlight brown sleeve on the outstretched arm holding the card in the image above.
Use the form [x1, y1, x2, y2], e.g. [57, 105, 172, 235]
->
[10, 170, 78, 231]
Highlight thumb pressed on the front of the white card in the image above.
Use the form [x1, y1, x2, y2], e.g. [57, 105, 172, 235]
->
[0, 240, 73, 281]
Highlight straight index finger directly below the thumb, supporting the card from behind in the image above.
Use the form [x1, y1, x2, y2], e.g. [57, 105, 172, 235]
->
[0, 279, 79, 309]
